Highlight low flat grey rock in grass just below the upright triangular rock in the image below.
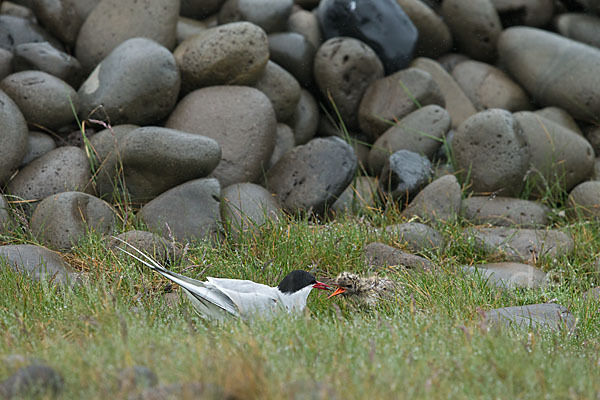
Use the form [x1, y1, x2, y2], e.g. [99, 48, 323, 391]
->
[385, 222, 445, 252]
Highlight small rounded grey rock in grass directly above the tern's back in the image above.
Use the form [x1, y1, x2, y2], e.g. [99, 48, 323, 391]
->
[221, 183, 283, 237]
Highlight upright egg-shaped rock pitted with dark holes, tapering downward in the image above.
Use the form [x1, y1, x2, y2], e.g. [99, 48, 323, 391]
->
[313, 37, 384, 130]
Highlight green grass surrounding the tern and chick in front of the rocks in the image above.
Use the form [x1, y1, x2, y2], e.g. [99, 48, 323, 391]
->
[0, 210, 600, 399]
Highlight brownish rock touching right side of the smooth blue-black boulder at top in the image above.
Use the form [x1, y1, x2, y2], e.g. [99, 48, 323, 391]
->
[396, 0, 452, 58]
